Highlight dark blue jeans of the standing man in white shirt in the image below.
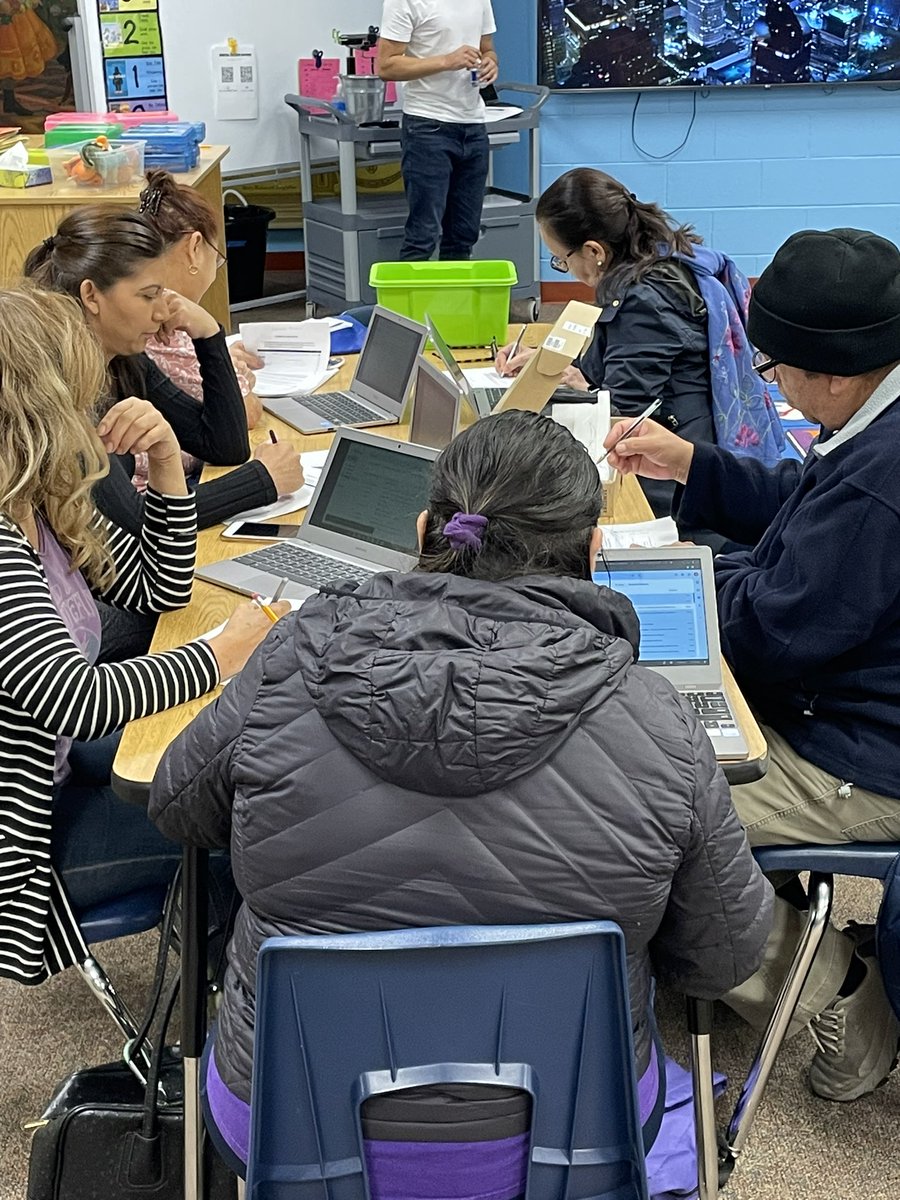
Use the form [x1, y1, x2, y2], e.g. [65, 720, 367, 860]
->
[400, 116, 488, 262]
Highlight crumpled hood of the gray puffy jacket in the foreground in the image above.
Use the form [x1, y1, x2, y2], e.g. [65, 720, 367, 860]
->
[307, 575, 638, 796]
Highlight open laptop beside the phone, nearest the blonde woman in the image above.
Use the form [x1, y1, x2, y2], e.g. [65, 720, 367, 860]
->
[194, 428, 437, 600]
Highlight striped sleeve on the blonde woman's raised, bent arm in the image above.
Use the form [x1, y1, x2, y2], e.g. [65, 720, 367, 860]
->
[98, 488, 197, 612]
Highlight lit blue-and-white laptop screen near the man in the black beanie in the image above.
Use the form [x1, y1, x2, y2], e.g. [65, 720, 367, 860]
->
[594, 558, 709, 667]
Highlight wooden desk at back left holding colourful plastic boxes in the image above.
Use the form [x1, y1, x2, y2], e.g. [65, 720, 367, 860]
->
[0, 138, 230, 332]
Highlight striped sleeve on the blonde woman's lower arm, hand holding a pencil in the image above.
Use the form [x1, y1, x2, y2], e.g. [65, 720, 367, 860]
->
[0, 538, 218, 740]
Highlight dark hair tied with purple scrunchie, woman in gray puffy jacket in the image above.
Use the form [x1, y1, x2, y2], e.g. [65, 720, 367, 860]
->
[419, 412, 602, 581]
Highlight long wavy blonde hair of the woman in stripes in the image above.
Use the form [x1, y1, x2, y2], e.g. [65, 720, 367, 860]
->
[0, 284, 115, 589]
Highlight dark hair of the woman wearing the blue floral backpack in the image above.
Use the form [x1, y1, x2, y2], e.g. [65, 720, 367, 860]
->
[535, 167, 702, 304]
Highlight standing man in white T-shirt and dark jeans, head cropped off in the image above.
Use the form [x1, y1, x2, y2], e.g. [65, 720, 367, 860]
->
[378, 0, 498, 262]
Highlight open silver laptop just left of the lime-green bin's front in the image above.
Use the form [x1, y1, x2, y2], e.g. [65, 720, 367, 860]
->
[263, 306, 427, 433]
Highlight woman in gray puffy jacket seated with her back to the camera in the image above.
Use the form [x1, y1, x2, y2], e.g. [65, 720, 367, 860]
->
[150, 412, 772, 1180]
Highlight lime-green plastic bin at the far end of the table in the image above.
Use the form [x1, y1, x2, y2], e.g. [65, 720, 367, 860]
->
[368, 259, 518, 346]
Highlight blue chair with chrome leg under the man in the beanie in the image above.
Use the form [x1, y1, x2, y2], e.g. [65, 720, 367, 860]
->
[720, 841, 900, 1177]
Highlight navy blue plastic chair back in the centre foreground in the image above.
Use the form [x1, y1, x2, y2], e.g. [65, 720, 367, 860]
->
[247, 922, 647, 1200]
